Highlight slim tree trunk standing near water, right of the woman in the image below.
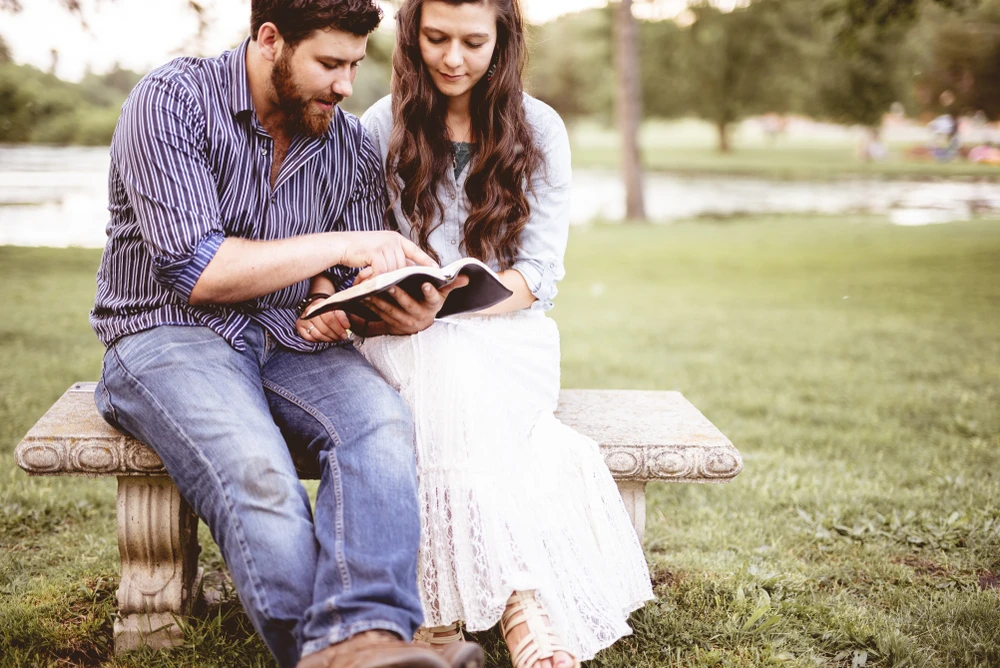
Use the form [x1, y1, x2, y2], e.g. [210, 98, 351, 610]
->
[615, 0, 646, 222]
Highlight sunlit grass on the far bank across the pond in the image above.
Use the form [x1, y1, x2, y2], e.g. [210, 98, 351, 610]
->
[570, 120, 1000, 181]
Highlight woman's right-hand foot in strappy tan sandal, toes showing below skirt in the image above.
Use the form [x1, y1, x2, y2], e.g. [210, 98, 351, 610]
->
[500, 591, 580, 668]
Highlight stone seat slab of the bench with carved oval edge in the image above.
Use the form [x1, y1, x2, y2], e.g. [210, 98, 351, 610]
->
[16, 383, 743, 482]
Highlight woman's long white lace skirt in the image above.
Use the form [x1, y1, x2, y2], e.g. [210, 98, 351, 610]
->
[358, 310, 653, 660]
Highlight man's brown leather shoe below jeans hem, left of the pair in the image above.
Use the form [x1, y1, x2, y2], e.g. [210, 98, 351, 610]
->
[297, 631, 450, 668]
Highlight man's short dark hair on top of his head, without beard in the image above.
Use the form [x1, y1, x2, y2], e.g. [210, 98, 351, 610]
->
[250, 0, 382, 48]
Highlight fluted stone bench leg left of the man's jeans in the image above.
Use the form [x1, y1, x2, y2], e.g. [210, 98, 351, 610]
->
[115, 476, 201, 654]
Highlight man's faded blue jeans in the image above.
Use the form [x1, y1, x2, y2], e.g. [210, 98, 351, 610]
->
[95, 324, 422, 666]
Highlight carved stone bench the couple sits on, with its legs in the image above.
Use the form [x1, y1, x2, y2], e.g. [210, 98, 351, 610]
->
[15, 383, 743, 653]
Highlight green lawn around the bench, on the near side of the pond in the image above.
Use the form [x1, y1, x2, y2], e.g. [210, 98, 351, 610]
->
[0, 217, 1000, 668]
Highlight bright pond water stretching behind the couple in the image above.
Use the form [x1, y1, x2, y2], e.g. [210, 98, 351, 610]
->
[0, 146, 1000, 248]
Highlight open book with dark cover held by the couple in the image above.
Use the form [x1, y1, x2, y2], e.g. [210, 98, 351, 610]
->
[303, 257, 514, 321]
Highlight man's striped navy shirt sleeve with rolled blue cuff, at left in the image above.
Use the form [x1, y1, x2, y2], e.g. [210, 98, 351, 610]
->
[114, 79, 225, 302]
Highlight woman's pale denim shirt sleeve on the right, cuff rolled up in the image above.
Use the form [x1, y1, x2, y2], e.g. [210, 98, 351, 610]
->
[513, 110, 572, 311]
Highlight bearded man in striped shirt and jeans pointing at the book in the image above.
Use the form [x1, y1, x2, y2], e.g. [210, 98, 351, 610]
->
[91, 0, 482, 668]
